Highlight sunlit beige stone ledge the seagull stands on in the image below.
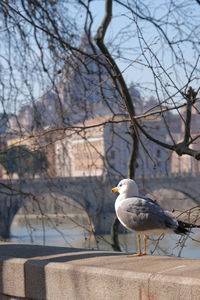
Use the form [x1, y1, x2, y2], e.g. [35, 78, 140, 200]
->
[0, 244, 200, 300]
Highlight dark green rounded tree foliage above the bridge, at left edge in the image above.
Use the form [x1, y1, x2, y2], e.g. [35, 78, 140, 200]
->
[0, 146, 48, 178]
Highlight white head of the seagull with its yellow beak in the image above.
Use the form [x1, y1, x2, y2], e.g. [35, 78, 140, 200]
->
[112, 178, 139, 198]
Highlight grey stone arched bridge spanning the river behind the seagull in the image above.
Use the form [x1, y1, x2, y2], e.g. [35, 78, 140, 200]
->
[0, 174, 200, 238]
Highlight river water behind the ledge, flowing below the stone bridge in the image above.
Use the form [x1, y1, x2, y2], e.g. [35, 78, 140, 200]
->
[11, 217, 200, 258]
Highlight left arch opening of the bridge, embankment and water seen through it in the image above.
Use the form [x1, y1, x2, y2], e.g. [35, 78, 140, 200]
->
[10, 193, 94, 246]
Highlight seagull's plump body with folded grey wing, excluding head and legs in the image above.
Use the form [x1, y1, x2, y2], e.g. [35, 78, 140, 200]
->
[117, 197, 178, 232]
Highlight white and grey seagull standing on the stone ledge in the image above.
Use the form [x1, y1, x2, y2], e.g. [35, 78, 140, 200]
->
[112, 179, 200, 257]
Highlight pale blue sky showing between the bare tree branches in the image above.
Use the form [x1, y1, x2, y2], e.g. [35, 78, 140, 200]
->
[1, 0, 200, 109]
